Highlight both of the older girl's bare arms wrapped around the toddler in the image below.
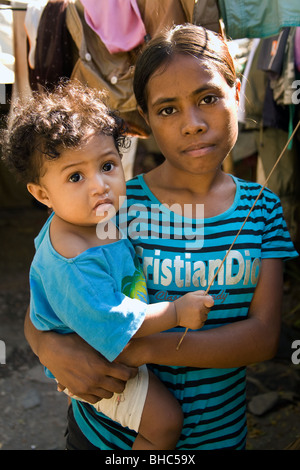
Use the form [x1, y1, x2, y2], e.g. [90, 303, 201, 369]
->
[25, 259, 282, 403]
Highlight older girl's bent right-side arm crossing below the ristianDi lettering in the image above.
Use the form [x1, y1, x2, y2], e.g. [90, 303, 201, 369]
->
[118, 259, 283, 368]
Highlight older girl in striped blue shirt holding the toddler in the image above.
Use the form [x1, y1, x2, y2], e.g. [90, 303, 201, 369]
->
[26, 25, 297, 450]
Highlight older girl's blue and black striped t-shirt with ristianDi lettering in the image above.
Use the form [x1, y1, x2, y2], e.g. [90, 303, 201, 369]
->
[73, 175, 297, 450]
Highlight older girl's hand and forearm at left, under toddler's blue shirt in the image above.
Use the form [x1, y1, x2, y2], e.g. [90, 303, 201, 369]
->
[24, 311, 136, 403]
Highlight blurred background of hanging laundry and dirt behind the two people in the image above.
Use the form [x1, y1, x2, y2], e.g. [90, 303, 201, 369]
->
[0, 0, 300, 450]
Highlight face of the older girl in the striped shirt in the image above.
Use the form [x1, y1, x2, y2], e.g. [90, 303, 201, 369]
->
[139, 54, 239, 174]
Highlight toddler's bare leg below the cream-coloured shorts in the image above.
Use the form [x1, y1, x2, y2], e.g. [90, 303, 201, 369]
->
[132, 371, 183, 450]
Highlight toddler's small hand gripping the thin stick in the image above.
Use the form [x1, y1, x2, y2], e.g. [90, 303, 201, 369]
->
[174, 291, 214, 330]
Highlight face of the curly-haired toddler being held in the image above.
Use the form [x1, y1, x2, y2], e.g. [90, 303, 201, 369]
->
[31, 134, 126, 226]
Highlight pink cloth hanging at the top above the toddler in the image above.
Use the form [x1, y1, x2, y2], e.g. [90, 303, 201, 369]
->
[81, 0, 146, 54]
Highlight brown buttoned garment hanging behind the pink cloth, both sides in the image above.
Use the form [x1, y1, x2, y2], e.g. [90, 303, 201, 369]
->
[66, 0, 199, 137]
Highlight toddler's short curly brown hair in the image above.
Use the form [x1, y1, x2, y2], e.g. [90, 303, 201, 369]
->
[1, 81, 128, 183]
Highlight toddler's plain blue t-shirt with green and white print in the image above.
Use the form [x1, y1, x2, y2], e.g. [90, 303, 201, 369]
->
[30, 214, 148, 361]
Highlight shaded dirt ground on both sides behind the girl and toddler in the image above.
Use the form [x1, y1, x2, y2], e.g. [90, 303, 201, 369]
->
[0, 200, 300, 450]
